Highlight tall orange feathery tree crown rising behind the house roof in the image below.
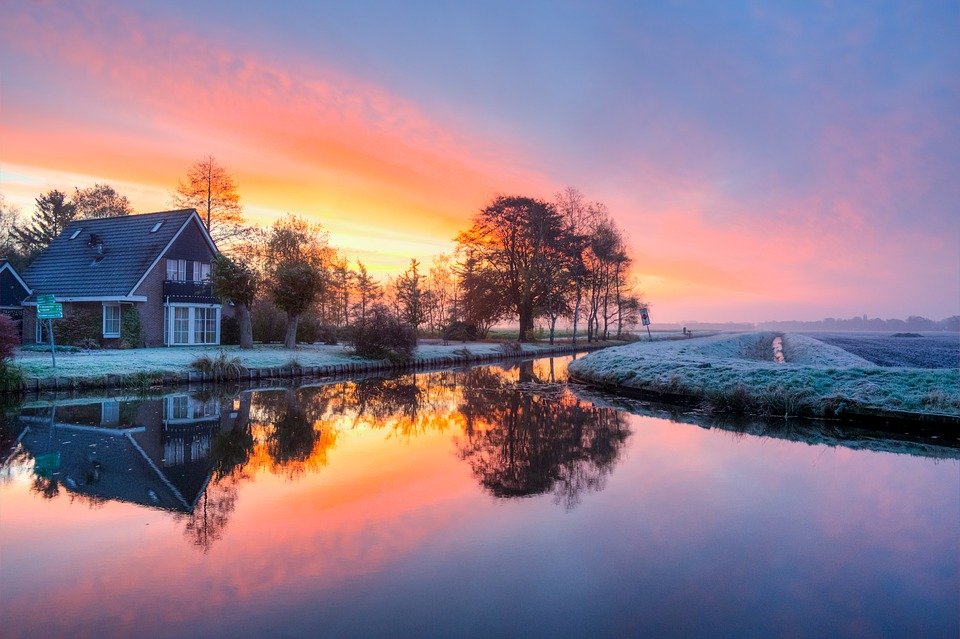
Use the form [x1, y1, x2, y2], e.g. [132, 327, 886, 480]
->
[173, 155, 247, 243]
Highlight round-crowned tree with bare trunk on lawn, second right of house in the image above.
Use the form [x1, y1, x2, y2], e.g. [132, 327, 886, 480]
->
[266, 215, 332, 349]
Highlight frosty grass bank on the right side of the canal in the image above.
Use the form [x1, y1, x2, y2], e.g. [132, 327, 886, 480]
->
[570, 333, 960, 417]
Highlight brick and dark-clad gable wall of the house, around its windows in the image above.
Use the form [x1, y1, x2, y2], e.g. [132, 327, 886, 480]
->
[133, 222, 220, 347]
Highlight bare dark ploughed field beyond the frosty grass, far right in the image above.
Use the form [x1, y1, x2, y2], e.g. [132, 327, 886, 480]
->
[806, 333, 960, 368]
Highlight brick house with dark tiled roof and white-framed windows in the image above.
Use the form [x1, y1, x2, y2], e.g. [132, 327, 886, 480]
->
[23, 209, 222, 348]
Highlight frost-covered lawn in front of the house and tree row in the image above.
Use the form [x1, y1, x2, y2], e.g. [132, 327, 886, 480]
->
[15, 342, 584, 378]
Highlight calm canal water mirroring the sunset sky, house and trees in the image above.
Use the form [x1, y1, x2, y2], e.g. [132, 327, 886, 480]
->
[0, 358, 960, 637]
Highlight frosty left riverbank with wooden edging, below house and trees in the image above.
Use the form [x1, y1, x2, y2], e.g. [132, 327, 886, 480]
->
[5, 342, 622, 393]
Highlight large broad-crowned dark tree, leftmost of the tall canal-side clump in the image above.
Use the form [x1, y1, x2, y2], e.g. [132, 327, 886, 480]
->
[457, 196, 563, 341]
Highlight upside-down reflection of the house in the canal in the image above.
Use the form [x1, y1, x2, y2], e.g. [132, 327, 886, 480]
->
[19, 393, 244, 514]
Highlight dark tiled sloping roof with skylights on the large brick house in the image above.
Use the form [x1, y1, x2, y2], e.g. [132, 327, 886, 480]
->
[23, 209, 213, 297]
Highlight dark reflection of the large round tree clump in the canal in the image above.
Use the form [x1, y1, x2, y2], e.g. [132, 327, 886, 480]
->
[458, 369, 630, 509]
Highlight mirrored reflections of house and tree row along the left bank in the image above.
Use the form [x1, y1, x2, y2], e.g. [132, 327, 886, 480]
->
[2, 359, 629, 550]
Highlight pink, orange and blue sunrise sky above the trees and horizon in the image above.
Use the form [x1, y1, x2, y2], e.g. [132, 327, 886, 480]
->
[0, 0, 960, 323]
